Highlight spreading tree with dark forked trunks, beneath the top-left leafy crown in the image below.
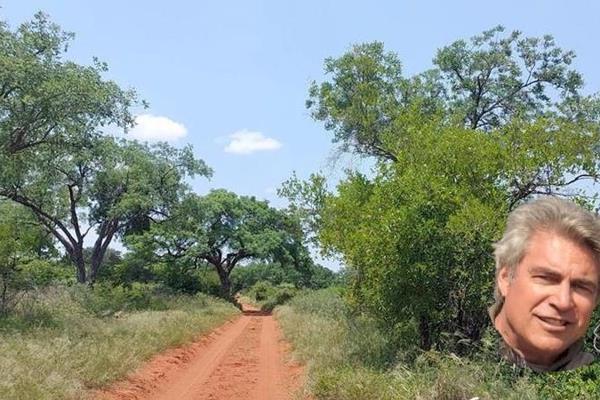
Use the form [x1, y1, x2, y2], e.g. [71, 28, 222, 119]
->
[0, 137, 210, 283]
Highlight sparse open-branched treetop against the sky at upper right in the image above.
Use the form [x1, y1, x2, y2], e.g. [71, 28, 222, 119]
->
[433, 26, 585, 130]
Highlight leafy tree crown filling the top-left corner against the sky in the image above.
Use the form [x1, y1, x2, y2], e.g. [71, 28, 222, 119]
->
[0, 13, 137, 158]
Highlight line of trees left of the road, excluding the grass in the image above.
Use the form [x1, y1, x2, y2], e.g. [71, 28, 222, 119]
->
[0, 13, 336, 312]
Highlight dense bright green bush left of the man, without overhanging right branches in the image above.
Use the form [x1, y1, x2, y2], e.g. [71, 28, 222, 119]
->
[319, 122, 505, 348]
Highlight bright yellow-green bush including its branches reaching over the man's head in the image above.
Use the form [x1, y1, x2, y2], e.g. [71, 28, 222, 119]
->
[312, 111, 600, 348]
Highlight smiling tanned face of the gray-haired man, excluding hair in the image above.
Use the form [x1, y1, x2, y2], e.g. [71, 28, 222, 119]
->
[496, 231, 599, 365]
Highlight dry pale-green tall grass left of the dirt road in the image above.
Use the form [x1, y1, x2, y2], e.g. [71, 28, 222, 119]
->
[0, 287, 238, 400]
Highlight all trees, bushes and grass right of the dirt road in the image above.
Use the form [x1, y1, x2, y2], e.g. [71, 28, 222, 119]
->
[280, 27, 600, 399]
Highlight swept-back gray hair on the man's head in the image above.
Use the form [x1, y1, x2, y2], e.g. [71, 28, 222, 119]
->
[490, 196, 600, 316]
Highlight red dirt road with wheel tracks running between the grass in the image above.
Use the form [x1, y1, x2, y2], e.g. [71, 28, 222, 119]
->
[96, 306, 302, 400]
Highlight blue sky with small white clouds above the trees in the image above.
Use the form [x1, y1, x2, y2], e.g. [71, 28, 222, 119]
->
[0, 0, 600, 268]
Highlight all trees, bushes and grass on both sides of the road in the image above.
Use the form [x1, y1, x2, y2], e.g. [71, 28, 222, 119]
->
[0, 13, 600, 399]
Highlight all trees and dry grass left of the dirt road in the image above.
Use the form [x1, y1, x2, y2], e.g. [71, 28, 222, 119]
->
[0, 13, 332, 399]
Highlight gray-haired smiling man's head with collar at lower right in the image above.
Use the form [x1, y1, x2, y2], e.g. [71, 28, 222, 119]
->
[490, 197, 600, 372]
